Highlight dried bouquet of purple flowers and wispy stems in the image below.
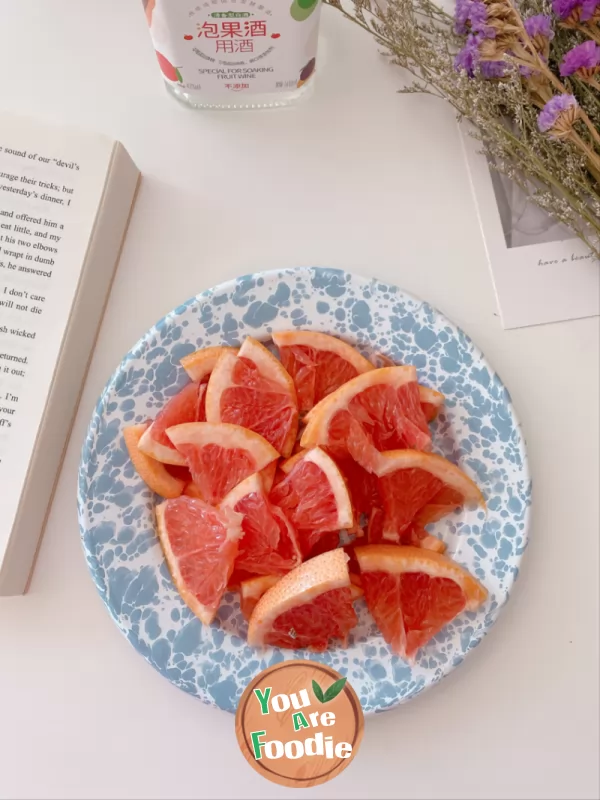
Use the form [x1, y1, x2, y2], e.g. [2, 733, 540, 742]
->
[325, 0, 600, 257]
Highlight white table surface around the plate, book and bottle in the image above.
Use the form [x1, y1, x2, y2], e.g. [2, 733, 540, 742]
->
[0, 0, 599, 800]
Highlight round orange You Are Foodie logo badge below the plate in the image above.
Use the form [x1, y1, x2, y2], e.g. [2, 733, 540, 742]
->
[235, 661, 364, 788]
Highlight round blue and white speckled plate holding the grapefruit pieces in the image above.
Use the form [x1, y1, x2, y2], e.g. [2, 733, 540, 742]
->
[78, 268, 531, 712]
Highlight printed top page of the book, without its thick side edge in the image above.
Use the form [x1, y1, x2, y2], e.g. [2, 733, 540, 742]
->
[0, 115, 113, 556]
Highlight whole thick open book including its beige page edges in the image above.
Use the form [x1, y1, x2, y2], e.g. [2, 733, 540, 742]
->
[0, 114, 139, 595]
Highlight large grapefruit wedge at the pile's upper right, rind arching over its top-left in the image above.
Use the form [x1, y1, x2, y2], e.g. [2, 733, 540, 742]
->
[300, 367, 431, 471]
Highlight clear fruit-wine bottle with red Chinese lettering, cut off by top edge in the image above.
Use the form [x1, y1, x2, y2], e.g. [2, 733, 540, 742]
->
[143, 0, 322, 109]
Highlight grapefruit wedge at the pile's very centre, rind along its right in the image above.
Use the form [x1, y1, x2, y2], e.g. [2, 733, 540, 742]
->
[269, 447, 354, 558]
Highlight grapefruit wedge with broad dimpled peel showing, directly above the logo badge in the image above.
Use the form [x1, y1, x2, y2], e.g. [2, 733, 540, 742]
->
[248, 549, 357, 651]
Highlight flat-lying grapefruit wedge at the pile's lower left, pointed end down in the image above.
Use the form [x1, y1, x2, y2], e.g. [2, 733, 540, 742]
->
[156, 497, 243, 625]
